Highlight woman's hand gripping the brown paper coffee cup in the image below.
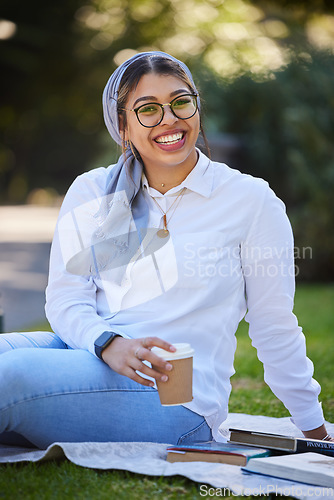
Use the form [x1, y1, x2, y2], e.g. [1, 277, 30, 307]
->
[102, 337, 176, 387]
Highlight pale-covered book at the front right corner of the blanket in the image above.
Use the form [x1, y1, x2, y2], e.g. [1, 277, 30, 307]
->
[242, 452, 334, 488]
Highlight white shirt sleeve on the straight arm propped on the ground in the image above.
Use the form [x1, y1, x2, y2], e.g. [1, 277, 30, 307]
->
[241, 185, 324, 431]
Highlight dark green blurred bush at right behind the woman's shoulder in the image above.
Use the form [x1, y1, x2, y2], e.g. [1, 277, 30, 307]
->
[198, 52, 334, 281]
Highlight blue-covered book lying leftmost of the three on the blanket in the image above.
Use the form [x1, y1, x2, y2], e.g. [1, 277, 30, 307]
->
[167, 441, 270, 465]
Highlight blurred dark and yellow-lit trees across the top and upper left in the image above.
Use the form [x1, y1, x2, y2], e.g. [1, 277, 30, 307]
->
[0, 0, 334, 202]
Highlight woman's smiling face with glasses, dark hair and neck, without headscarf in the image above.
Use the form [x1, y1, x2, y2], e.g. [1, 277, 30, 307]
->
[117, 57, 208, 193]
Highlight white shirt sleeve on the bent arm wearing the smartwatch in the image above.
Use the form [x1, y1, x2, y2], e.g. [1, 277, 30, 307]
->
[45, 169, 127, 355]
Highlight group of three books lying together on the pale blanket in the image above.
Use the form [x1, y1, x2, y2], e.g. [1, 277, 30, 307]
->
[167, 429, 334, 488]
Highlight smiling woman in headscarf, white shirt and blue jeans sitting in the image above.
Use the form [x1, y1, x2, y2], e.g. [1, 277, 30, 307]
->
[0, 52, 329, 447]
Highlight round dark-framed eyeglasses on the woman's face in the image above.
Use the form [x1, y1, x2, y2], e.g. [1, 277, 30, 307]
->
[123, 94, 198, 128]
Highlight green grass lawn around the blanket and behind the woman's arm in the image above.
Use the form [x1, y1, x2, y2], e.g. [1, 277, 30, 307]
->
[0, 285, 334, 500]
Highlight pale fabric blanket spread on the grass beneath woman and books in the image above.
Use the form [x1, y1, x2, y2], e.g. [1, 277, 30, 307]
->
[0, 413, 334, 500]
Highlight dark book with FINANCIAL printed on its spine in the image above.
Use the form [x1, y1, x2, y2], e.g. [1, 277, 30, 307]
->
[229, 429, 334, 457]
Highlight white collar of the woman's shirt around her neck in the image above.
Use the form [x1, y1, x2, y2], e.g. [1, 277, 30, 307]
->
[142, 148, 213, 198]
